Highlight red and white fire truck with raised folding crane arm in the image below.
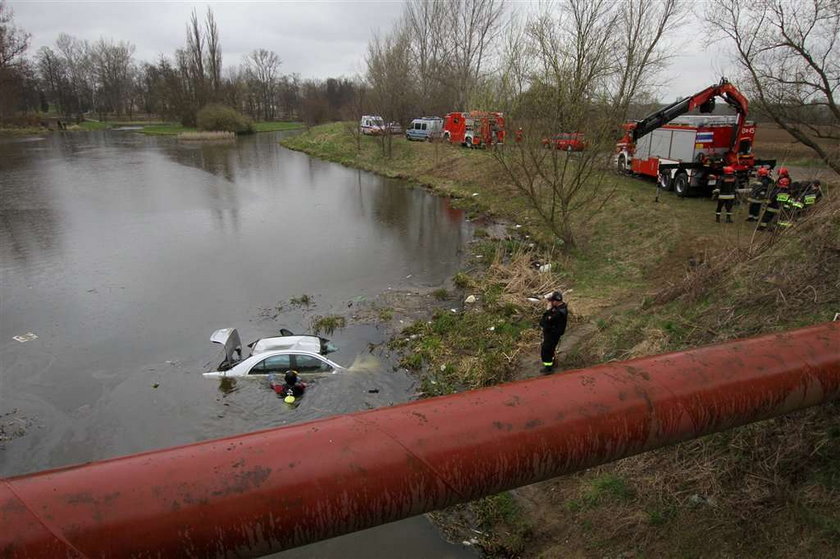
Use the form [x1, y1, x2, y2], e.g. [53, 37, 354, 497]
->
[615, 79, 776, 196]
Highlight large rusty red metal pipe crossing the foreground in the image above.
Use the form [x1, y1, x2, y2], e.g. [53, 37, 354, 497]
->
[0, 323, 840, 557]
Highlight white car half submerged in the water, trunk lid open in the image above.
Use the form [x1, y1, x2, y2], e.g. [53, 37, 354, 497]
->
[204, 328, 344, 378]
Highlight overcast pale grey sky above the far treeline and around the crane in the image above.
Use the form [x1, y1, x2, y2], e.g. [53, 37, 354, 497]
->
[8, 0, 728, 100]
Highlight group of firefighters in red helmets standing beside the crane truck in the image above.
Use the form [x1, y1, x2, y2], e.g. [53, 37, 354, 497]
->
[715, 166, 822, 231]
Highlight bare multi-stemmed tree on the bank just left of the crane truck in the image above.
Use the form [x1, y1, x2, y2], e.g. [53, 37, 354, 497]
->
[494, 0, 679, 248]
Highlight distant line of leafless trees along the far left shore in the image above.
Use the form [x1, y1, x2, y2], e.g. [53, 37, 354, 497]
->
[0, 1, 356, 126]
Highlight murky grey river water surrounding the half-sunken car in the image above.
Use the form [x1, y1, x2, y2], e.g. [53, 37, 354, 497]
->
[0, 131, 480, 557]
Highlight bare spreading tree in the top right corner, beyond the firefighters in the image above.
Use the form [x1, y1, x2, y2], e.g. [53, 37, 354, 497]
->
[707, 0, 840, 174]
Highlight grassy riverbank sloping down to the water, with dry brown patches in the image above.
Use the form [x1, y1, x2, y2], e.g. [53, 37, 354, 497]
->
[290, 124, 840, 557]
